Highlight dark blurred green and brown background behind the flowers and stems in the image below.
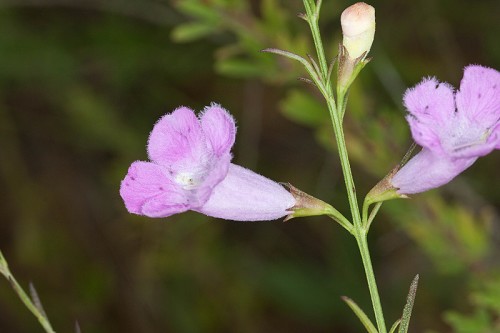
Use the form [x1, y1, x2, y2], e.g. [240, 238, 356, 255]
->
[0, 0, 500, 333]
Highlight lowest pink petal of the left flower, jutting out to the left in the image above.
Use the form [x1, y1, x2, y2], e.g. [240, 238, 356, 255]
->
[120, 161, 189, 217]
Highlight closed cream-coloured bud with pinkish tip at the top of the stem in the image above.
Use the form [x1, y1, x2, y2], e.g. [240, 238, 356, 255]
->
[340, 2, 375, 59]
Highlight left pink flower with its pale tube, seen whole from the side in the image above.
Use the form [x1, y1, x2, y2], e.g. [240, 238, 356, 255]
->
[120, 104, 295, 221]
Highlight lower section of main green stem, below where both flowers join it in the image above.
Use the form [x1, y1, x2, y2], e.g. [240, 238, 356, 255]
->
[355, 229, 387, 333]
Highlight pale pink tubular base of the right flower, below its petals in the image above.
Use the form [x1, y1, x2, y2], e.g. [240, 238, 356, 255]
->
[391, 148, 477, 194]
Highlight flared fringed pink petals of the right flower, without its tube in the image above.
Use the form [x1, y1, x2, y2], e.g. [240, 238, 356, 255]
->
[404, 65, 499, 158]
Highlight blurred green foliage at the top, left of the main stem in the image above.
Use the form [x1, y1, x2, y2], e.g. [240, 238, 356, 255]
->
[172, 0, 308, 82]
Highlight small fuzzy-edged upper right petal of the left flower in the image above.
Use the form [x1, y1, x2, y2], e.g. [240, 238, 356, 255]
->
[201, 104, 236, 156]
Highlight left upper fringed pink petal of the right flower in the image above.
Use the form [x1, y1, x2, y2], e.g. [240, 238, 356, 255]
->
[404, 78, 455, 153]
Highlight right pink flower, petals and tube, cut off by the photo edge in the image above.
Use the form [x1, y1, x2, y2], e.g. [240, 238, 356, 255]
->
[392, 65, 500, 194]
